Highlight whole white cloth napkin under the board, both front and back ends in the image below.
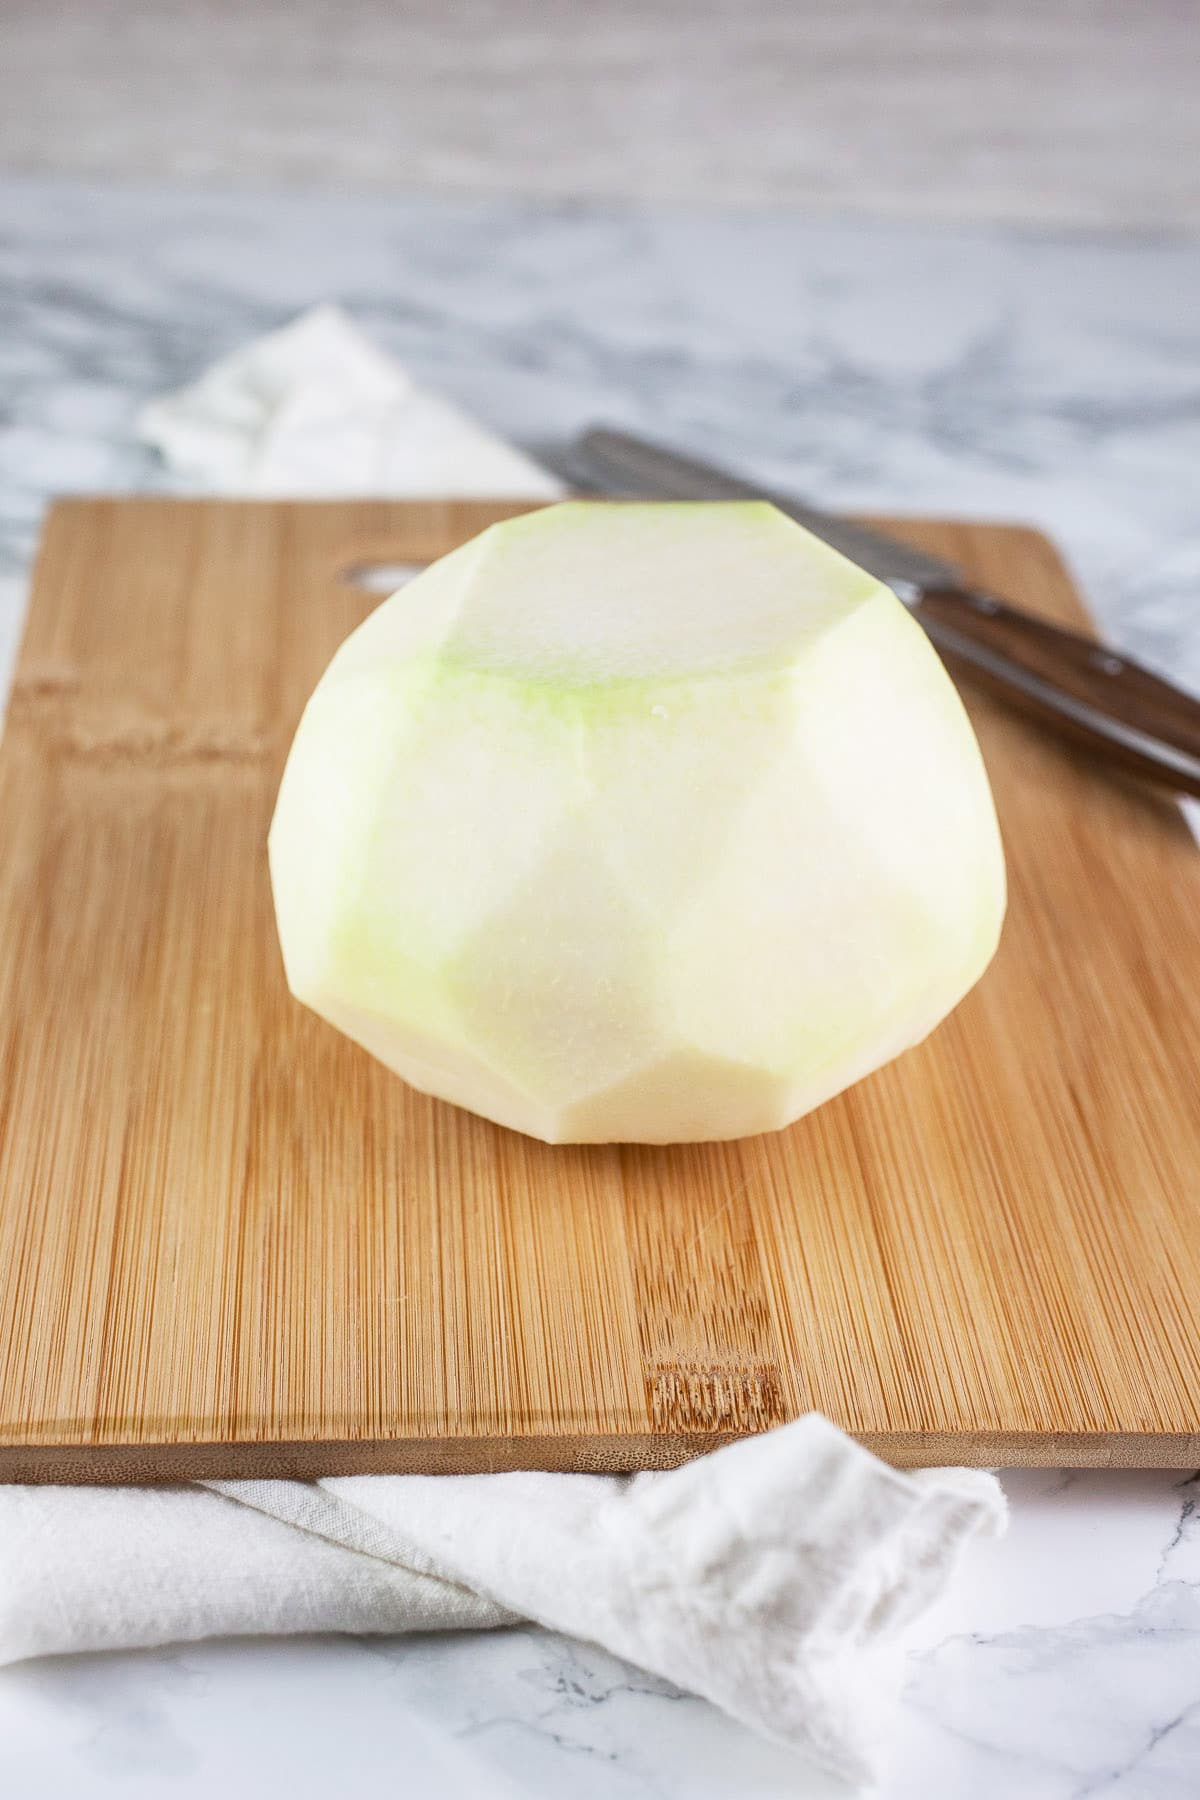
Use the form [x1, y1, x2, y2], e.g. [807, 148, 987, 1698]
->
[0, 306, 1004, 1780]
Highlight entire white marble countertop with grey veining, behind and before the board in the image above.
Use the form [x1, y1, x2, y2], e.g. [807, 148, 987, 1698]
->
[0, 182, 1200, 1800]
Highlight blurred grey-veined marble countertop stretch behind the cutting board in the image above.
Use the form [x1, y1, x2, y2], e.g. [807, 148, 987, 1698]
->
[0, 182, 1200, 684]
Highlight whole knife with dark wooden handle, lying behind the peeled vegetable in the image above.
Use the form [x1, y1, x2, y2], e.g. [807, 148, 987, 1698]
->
[563, 427, 1200, 797]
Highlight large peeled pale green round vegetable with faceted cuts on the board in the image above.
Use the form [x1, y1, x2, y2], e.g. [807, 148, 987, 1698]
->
[270, 504, 1004, 1141]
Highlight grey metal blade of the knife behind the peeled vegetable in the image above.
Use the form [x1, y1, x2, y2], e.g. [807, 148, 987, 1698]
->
[572, 427, 963, 598]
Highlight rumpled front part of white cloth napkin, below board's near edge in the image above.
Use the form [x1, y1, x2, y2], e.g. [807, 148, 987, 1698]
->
[0, 1415, 1004, 1782]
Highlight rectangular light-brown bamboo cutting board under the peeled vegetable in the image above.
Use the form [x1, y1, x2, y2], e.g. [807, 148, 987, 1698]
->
[0, 500, 1200, 1481]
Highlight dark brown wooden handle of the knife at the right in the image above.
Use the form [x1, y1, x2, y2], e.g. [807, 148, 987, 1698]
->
[912, 587, 1200, 796]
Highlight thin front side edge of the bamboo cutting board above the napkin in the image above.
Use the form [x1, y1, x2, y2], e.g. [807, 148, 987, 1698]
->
[0, 1431, 1200, 1487]
